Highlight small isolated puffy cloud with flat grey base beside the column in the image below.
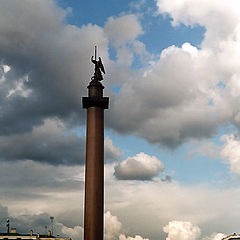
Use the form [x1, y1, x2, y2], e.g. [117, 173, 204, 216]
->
[114, 152, 164, 180]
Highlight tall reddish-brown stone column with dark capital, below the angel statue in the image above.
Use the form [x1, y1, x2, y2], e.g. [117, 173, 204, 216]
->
[83, 80, 109, 240]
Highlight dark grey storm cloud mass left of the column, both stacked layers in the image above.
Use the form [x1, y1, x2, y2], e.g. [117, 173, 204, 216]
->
[0, 0, 124, 165]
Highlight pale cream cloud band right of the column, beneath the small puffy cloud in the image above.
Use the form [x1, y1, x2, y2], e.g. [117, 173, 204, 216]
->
[105, 165, 240, 239]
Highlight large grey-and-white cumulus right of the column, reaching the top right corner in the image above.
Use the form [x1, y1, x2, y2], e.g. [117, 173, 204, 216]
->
[104, 0, 240, 148]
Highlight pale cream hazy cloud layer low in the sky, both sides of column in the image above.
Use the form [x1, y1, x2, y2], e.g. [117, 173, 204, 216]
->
[0, 158, 237, 239]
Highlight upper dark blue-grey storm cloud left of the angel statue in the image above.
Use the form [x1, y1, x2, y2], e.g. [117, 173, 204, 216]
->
[0, 0, 109, 135]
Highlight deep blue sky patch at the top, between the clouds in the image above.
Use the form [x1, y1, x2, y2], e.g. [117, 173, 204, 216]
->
[57, 0, 205, 50]
